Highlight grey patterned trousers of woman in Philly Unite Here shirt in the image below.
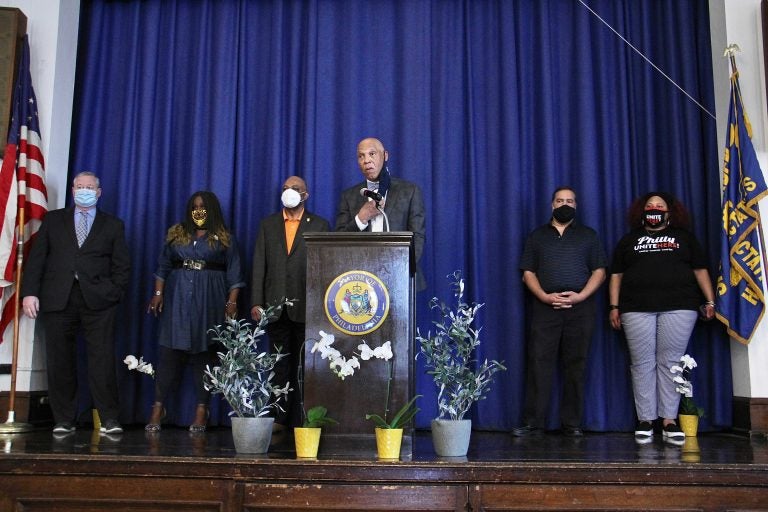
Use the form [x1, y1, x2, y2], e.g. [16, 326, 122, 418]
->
[621, 310, 698, 421]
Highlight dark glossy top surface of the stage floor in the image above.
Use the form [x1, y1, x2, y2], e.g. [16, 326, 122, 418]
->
[0, 425, 768, 465]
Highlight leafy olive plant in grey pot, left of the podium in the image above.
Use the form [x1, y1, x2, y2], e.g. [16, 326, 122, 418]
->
[204, 301, 290, 453]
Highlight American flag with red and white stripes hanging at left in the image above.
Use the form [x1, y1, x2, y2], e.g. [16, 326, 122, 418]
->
[0, 36, 48, 342]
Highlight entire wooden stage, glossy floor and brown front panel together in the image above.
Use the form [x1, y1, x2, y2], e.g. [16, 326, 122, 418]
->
[0, 425, 768, 512]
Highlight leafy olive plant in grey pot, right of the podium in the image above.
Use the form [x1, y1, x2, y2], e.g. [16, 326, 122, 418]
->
[416, 271, 506, 457]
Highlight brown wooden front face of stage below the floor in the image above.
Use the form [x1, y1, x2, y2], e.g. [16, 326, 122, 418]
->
[0, 454, 768, 511]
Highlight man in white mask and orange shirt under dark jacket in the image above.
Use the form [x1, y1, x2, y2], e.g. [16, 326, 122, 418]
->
[251, 176, 328, 430]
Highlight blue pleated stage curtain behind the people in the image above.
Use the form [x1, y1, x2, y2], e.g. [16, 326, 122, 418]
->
[70, 0, 732, 431]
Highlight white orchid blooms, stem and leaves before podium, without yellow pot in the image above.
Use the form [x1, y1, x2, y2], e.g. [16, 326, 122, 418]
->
[311, 331, 421, 428]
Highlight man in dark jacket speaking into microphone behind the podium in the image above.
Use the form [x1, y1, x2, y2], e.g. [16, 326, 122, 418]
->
[336, 137, 426, 290]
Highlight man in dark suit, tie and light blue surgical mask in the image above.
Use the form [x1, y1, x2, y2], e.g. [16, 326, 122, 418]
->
[21, 172, 130, 434]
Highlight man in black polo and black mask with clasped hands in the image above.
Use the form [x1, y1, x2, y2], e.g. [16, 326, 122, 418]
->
[512, 187, 607, 436]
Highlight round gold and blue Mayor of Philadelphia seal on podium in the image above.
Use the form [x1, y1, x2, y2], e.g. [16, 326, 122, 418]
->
[325, 270, 389, 336]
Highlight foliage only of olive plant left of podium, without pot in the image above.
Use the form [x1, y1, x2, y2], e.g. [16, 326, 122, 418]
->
[204, 300, 292, 418]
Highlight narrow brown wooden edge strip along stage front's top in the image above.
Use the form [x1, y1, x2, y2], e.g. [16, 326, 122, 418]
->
[0, 453, 768, 488]
